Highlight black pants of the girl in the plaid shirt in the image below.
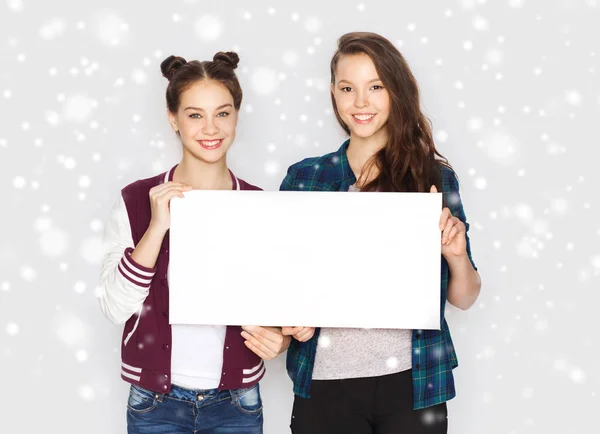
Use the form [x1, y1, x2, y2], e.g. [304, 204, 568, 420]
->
[290, 370, 448, 434]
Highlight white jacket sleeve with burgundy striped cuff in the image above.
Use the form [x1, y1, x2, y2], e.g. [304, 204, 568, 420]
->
[99, 197, 156, 324]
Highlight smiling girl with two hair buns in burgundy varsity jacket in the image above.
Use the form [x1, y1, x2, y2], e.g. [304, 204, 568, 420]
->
[100, 52, 290, 434]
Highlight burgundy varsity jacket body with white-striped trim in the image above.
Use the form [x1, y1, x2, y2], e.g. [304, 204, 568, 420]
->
[110, 166, 265, 393]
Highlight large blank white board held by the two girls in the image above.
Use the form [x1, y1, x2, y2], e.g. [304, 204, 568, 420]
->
[169, 190, 442, 329]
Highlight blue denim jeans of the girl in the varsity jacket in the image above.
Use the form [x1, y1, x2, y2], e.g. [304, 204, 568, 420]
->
[127, 384, 263, 434]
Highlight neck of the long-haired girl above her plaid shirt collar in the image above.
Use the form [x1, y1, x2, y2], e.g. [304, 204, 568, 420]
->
[346, 128, 388, 186]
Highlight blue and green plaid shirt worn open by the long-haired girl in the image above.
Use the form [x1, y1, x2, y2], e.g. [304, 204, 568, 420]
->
[280, 140, 477, 410]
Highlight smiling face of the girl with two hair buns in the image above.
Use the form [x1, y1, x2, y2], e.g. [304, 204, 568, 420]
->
[169, 80, 238, 163]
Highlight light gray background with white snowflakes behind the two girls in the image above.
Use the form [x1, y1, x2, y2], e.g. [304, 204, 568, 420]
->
[0, 0, 600, 434]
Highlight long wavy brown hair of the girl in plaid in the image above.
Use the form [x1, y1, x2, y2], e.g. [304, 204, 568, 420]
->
[331, 32, 450, 192]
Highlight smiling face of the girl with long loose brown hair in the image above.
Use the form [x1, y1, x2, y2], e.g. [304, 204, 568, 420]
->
[331, 53, 390, 141]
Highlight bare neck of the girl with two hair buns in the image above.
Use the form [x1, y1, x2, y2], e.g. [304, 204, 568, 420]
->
[173, 155, 232, 190]
